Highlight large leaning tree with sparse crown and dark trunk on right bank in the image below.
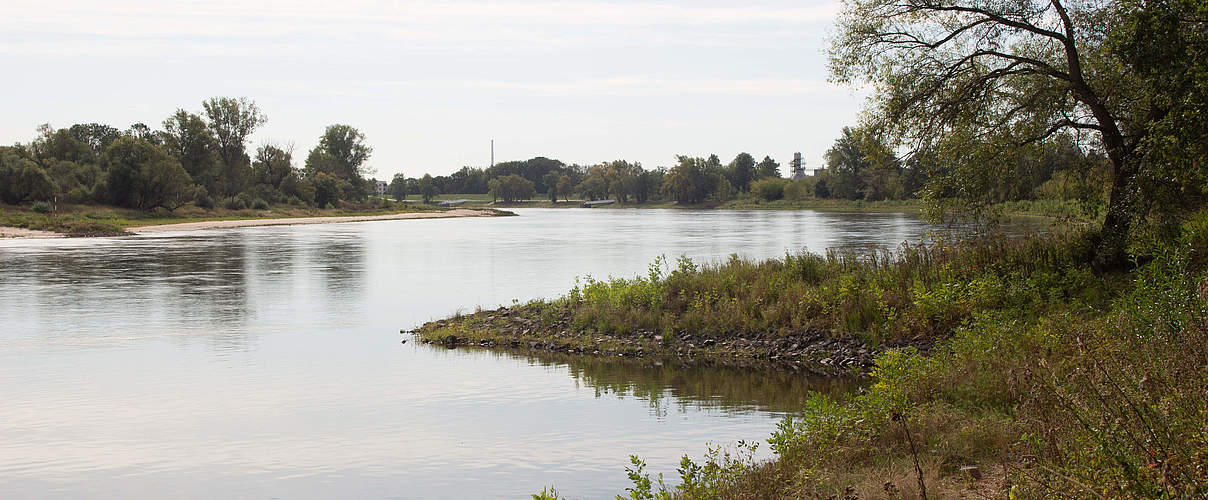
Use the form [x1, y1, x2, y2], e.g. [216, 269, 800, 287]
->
[830, 0, 1202, 269]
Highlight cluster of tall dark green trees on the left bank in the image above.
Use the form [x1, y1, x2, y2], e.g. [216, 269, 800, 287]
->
[0, 98, 373, 210]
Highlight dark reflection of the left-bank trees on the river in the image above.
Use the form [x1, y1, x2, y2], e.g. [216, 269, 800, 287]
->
[0, 228, 366, 350]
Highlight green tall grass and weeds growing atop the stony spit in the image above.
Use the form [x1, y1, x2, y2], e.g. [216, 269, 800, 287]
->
[559, 228, 1108, 343]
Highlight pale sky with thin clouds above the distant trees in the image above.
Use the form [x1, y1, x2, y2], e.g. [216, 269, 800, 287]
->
[0, 0, 864, 179]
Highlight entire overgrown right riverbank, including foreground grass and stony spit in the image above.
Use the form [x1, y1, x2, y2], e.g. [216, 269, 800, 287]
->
[417, 214, 1208, 498]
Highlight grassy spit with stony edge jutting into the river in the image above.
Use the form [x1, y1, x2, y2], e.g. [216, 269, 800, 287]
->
[414, 233, 1086, 376]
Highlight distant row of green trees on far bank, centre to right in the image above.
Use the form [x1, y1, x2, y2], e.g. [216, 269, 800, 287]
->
[388, 127, 1110, 210]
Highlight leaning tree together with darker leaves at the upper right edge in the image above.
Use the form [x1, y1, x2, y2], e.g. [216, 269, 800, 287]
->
[831, 0, 1208, 271]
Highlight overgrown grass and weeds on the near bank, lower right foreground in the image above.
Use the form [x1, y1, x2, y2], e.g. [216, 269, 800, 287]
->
[604, 213, 1208, 499]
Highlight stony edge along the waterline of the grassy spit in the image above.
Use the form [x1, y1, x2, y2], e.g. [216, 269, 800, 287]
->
[403, 306, 933, 377]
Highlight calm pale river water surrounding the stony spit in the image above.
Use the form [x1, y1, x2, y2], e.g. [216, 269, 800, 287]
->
[0, 209, 927, 499]
